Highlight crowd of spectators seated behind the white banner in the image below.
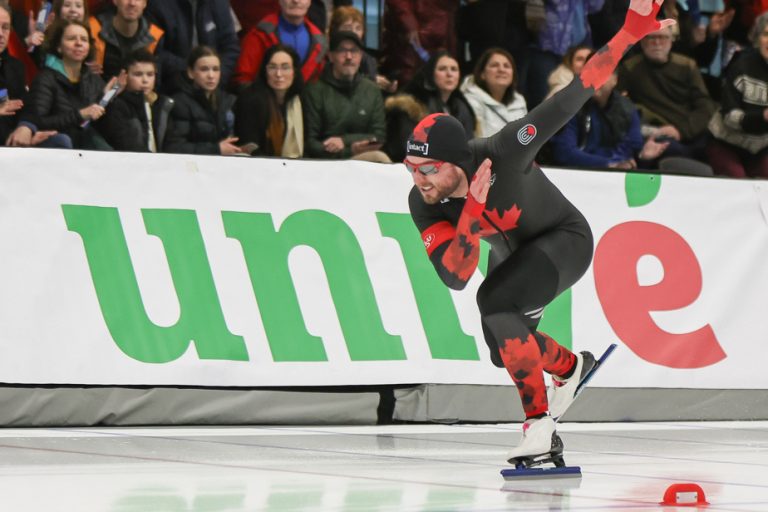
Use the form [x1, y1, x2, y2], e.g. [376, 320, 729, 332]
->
[0, 0, 768, 178]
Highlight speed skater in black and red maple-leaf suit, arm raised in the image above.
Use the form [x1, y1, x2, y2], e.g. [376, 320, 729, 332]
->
[405, 0, 674, 464]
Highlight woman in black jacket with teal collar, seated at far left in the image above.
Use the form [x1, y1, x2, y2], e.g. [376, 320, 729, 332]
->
[22, 19, 117, 149]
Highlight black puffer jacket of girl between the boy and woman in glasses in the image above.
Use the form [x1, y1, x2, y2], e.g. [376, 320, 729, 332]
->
[163, 83, 235, 155]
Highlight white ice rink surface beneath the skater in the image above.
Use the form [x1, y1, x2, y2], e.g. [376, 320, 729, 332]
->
[0, 422, 768, 512]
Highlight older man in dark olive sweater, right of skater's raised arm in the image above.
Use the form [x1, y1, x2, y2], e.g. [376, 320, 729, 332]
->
[618, 27, 716, 161]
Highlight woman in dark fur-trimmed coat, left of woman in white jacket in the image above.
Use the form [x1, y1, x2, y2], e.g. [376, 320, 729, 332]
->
[384, 51, 476, 162]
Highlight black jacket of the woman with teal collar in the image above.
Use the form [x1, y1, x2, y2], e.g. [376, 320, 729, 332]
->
[22, 66, 105, 144]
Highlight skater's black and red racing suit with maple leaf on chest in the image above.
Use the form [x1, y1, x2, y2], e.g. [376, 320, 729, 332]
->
[409, 78, 594, 417]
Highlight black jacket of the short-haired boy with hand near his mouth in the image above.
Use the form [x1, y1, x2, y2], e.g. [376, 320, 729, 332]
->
[99, 91, 173, 152]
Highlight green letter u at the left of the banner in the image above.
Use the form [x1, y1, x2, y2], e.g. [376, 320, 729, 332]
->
[61, 205, 248, 363]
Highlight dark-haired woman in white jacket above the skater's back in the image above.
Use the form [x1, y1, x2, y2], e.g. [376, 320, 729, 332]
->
[461, 48, 528, 137]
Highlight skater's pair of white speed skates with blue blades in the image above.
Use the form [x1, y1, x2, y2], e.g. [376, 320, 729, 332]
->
[501, 343, 616, 480]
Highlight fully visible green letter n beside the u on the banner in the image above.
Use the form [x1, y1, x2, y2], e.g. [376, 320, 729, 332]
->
[222, 210, 405, 361]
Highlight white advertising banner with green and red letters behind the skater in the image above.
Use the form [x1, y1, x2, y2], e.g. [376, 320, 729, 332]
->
[0, 148, 768, 389]
